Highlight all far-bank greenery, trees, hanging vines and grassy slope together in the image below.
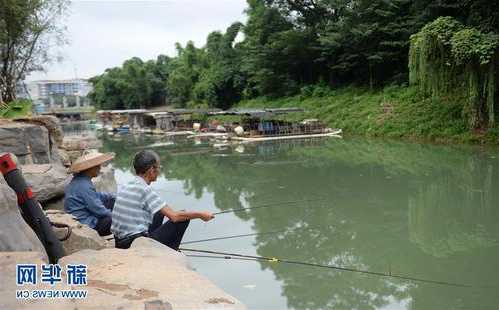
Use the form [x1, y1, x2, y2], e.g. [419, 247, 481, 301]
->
[91, 0, 499, 142]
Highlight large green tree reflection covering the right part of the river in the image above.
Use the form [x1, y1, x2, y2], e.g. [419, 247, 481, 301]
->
[102, 140, 499, 309]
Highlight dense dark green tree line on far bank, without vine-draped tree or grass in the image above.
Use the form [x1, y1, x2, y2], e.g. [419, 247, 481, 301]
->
[88, 0, 499, 123]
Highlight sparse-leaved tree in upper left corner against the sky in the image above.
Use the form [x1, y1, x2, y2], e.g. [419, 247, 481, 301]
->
[0, 0, 68, 103]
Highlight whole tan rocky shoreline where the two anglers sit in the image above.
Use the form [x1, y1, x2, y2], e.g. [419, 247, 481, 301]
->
[0, 116, 245, 309]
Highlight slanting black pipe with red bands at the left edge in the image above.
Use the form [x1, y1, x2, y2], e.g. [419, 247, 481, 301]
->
[0, 153, 64, 264]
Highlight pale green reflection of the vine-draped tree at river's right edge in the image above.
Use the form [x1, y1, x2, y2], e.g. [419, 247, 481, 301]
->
[409, 158, 499, 257]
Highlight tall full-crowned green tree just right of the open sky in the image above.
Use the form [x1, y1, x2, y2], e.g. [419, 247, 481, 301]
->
[241, 0, 313, 97]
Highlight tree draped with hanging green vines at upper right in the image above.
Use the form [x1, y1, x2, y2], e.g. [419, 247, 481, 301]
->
[409, 17, 499, 128]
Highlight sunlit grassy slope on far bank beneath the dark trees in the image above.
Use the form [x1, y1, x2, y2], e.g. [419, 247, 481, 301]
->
[238, 86, 499, 144]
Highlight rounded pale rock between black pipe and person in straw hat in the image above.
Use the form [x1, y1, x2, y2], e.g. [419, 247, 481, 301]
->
[21, 164, 71, 202]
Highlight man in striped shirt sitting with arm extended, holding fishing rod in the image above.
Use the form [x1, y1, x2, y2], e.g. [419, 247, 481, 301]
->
[111, 150, 214, 250]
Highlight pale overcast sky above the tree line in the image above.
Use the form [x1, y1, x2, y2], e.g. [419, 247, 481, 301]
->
[28, 0, 246, 81]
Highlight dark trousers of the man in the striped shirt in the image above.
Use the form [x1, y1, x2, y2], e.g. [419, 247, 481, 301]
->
[115, 211, 189, 250]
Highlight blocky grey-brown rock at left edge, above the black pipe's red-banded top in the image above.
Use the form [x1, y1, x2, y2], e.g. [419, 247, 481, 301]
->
[0, 122, 52, 164]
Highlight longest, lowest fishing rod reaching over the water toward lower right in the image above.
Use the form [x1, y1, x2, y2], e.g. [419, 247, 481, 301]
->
[179, 248, 473, 287]
